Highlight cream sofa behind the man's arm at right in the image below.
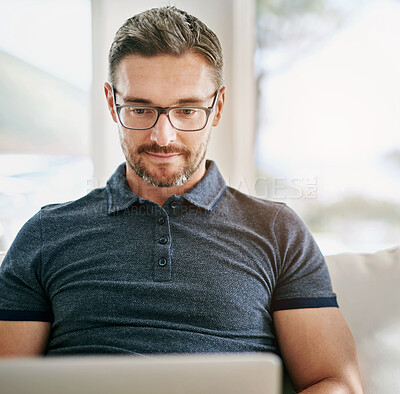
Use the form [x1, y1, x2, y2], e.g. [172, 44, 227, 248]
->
[0, 246, 400, 394]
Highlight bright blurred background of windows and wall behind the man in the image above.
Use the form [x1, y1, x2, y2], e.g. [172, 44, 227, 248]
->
[0, 0, 400, 254]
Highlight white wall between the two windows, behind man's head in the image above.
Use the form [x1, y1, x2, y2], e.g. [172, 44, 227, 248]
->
[91, 0, 255, 191]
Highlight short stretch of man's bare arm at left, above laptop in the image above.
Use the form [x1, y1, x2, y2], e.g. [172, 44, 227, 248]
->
[0, 321, 51, 357]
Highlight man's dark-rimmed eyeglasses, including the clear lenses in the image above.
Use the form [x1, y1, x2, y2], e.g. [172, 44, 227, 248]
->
[111, 85, 220, 131]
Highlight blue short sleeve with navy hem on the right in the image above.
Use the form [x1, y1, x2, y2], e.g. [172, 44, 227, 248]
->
[271, 205, 338, 311]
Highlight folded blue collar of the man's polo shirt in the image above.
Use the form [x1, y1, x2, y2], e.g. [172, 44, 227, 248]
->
[106, 160, 226, 215]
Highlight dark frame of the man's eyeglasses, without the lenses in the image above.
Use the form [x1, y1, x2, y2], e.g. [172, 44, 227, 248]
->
[110, 83, 221, 133]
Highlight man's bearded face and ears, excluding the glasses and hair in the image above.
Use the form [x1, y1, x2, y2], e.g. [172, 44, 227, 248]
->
[106, 54, 223, 187]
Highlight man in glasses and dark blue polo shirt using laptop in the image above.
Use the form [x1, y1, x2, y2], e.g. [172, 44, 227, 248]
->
[0, 7, 362, 393]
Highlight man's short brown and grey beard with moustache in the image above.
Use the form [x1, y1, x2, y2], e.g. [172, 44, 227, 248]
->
[120, 130, 211, 187]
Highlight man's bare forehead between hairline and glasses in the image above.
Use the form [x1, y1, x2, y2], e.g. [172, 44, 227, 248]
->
[116, 53, 215, 105]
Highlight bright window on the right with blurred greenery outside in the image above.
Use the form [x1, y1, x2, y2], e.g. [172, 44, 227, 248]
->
[255, 0, 400, 254]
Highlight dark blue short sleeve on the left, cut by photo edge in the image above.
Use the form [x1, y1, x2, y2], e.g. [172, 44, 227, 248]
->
[0, 212, 53, 322]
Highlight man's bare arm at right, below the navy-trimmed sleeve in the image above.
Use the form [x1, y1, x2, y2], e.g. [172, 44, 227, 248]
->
[273, 308, 363, 394]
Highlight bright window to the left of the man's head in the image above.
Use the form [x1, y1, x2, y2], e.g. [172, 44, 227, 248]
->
[0, 0, 92, 250]
